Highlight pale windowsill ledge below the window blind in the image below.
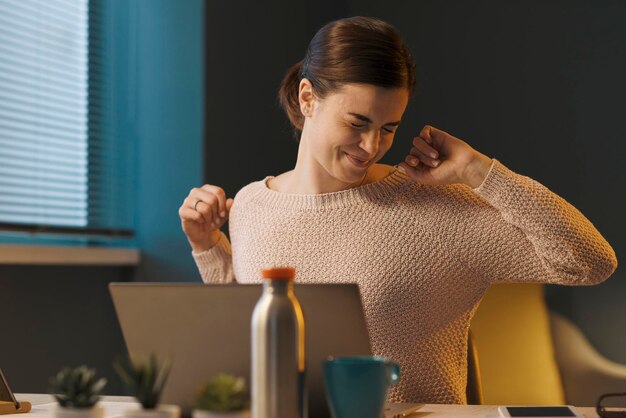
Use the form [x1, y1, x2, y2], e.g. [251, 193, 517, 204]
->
[0, 244, 140, 266]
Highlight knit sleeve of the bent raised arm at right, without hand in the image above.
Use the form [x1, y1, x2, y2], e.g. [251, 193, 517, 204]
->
[462, 159, 617, 285]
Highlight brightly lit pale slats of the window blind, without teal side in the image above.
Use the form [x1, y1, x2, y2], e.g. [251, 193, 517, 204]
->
[0, 0, 88, 227]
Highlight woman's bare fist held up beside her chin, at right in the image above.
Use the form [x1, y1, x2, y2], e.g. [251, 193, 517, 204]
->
[398, 125, 492, 188]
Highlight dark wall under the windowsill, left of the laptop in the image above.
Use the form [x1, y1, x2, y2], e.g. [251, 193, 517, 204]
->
[0, 265, 132, 394]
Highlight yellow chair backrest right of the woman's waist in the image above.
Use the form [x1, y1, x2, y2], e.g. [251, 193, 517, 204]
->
[471, 283, 565, 405]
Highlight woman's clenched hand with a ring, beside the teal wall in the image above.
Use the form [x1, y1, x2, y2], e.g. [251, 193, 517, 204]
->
[178, 184, 233, 252]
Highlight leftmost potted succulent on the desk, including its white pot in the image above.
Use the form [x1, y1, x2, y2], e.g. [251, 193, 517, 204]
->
[50, 365, 107, 418]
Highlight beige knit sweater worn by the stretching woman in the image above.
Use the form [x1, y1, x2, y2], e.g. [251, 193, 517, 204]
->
[192, 159, 617, 403]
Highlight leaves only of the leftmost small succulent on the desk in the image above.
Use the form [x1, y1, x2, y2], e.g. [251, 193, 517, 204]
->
[50, 365, 107, 408]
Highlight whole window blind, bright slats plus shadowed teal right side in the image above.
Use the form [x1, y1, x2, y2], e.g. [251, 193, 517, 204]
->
[0, 0, 134, 242]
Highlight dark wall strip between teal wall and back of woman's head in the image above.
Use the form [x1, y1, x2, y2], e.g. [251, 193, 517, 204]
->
[205, 0, 348, 197]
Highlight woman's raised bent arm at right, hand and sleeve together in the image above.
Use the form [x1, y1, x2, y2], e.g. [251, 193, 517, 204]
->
[399, 125, 617, 284]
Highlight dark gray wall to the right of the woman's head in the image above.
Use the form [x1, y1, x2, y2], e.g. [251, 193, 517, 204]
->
[351, 0, 626, 363]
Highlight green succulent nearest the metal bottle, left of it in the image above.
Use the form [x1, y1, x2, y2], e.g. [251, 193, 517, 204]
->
[196, 373, 247, 412]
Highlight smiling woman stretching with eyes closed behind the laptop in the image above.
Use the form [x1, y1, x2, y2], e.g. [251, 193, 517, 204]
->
[179, 17, 617, 403]
